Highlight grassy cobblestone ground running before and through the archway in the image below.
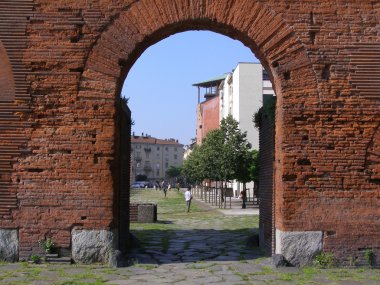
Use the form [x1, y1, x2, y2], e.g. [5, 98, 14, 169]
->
[0, 187, 380, 285]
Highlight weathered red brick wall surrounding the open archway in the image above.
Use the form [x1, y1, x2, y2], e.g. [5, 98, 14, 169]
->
[0, 0, 380, 262]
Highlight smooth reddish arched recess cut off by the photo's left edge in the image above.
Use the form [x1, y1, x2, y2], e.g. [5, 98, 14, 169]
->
[0, 41, 15, 101]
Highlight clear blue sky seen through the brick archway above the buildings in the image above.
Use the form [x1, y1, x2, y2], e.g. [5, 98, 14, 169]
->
[122, 31, 257, 144]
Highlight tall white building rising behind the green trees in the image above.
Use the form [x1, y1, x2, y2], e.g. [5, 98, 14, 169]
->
[219, 63, 274, 196]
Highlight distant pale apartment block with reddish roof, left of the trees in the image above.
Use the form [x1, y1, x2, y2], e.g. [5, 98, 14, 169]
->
[131, 135, 184, 181]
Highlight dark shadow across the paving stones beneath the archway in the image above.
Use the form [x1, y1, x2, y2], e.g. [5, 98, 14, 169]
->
[127, 228, 266, 264]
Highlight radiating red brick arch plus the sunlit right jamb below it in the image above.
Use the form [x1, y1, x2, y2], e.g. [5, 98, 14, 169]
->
[78, 1, 319, 256]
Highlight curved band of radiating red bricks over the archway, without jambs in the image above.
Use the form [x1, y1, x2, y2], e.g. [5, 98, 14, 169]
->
[80, 0, 318, 96]
